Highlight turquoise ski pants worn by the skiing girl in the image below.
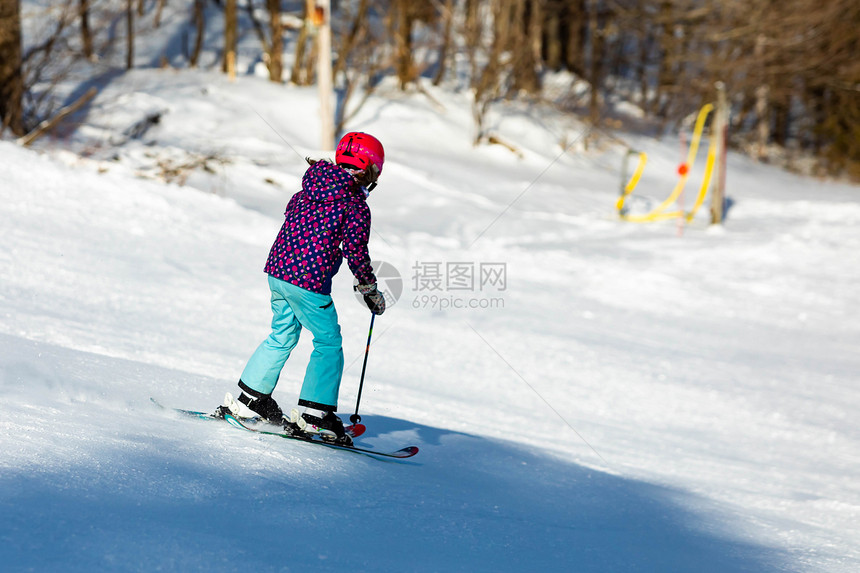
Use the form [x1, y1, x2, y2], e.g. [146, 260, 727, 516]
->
[242, 276, 343, 409]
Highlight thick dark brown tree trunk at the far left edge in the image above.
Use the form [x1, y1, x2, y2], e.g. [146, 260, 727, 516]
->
[0, 0, 24, 136]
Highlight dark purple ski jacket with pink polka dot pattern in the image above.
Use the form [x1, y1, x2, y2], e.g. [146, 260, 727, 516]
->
[266, 161, 376, 294]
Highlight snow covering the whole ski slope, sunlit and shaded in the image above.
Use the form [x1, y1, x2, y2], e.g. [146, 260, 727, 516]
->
[0, 62, 860, 572]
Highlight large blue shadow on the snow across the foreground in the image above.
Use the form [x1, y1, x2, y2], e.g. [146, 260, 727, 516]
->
[0, 416, 785, 572]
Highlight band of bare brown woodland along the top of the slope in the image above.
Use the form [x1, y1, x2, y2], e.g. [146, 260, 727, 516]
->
[5, 0, 860, 179]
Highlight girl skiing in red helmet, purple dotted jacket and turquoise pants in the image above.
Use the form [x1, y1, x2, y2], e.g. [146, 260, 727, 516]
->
[224, 132, 385, 443]
